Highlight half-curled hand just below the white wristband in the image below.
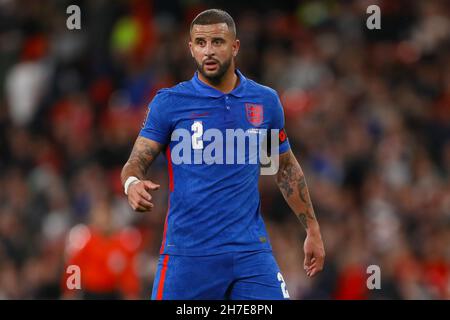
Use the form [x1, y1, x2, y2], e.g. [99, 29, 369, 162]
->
[128, 180, 160, 212]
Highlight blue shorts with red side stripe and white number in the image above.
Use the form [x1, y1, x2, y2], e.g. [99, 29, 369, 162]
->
[152, 251, 289, 300]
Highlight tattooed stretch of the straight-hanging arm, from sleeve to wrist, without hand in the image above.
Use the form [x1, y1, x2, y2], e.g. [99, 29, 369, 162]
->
[276, 150, 320, 234]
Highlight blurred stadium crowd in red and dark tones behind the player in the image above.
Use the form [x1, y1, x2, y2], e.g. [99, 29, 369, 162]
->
[0, 0, 450, 299]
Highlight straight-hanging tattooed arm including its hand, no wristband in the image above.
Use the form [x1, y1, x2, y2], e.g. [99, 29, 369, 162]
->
[276, 150, 325, 276]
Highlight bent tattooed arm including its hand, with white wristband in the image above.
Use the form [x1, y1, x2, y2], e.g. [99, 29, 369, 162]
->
[121, 137, 163, 212]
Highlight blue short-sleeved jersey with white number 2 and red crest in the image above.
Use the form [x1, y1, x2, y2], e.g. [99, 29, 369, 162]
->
[140, 70, 290, 256]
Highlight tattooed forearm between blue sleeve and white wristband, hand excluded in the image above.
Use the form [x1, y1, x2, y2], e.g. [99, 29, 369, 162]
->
[120, 137, 163, 184]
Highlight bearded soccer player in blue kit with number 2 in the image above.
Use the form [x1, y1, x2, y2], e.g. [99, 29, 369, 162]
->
[121, 9, 325, 300]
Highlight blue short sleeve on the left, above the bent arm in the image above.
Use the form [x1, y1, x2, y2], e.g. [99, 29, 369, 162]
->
[139, 91, 172, 145]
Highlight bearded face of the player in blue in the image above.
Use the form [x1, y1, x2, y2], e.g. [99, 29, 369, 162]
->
[189, 23, 239, 83]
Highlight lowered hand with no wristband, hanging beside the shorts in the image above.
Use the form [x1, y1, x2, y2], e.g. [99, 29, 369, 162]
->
[303, 232, 325, 277]
